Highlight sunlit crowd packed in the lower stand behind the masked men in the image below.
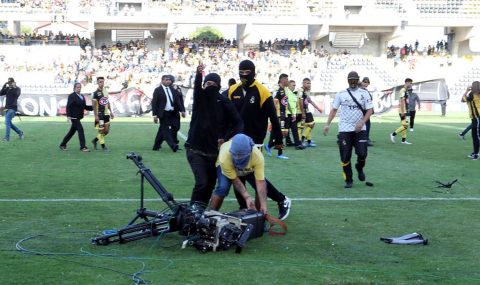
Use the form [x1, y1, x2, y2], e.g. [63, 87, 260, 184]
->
[0, 33, 464, 94]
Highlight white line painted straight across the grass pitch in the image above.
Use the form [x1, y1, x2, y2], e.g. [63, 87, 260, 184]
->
[0, 197, 480, 203]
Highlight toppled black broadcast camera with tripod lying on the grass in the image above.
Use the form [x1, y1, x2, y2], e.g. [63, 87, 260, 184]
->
[92, 152, 265, 253]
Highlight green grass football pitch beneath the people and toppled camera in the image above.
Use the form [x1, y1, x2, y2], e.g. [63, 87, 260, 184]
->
[0, 113, 480, 284]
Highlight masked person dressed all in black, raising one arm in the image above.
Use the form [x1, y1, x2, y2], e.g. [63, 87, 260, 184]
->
[185, 65, 243, 206]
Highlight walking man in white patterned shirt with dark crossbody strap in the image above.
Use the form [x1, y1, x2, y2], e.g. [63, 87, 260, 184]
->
[323, 71, 373, 188]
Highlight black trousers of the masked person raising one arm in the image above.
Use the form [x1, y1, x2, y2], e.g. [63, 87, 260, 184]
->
[187, 150, 217, 205]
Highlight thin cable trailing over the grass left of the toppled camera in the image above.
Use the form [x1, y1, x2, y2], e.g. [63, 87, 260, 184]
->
[15, 232, 150, 285]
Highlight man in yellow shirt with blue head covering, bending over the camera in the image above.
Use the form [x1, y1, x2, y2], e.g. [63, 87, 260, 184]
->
[210, 134, 267, 214]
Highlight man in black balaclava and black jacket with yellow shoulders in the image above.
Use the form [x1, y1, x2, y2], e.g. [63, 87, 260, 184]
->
[224, 60, 291, 220]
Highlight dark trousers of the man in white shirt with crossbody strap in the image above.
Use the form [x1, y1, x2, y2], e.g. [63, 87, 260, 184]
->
[338, 131, 368, 182]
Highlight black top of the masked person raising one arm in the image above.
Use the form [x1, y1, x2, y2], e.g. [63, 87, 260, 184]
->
[185, 73, 243, 155]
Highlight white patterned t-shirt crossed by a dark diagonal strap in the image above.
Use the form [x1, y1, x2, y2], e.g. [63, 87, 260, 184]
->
[332, 88, 373, 132]
